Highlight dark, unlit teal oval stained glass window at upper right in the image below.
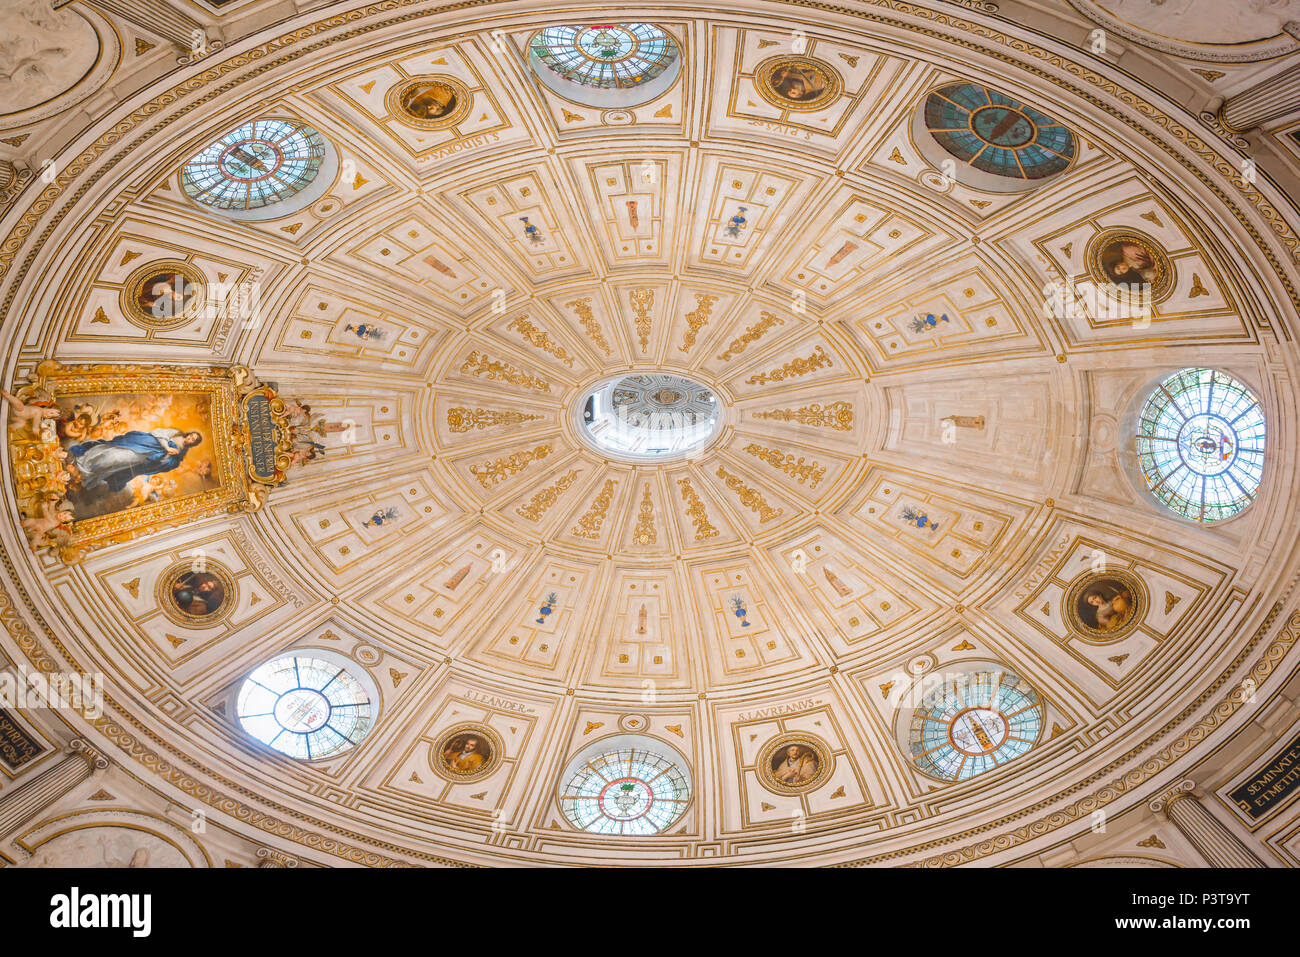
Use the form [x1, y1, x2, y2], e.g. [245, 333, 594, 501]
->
[926, 83, 1078, 179]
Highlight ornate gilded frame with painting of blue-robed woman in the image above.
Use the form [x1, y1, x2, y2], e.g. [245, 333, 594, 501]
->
[8, 360, 293, 563]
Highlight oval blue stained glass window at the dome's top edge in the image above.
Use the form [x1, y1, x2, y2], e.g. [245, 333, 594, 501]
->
[532, 23, 677, 90]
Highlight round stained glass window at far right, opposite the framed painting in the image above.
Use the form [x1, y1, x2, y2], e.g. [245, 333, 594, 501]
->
[1138, 369, 1265, 521]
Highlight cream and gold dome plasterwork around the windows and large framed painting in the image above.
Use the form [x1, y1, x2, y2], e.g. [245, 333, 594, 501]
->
[0, 4, 1296, 863]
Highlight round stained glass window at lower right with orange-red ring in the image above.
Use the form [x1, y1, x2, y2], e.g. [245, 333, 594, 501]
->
[909, 671, 1043, 781]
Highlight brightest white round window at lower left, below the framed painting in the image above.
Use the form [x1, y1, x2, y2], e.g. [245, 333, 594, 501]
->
[238, 655, 374, 761]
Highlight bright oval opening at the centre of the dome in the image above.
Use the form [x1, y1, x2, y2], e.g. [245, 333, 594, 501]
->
[579, 373, 722, 462]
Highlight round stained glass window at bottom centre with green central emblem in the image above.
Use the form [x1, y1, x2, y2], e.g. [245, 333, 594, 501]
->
[560, 748, 690, 835]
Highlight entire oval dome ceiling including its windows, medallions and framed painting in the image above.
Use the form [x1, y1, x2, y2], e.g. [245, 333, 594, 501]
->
[0, 3, 1300, 866]
